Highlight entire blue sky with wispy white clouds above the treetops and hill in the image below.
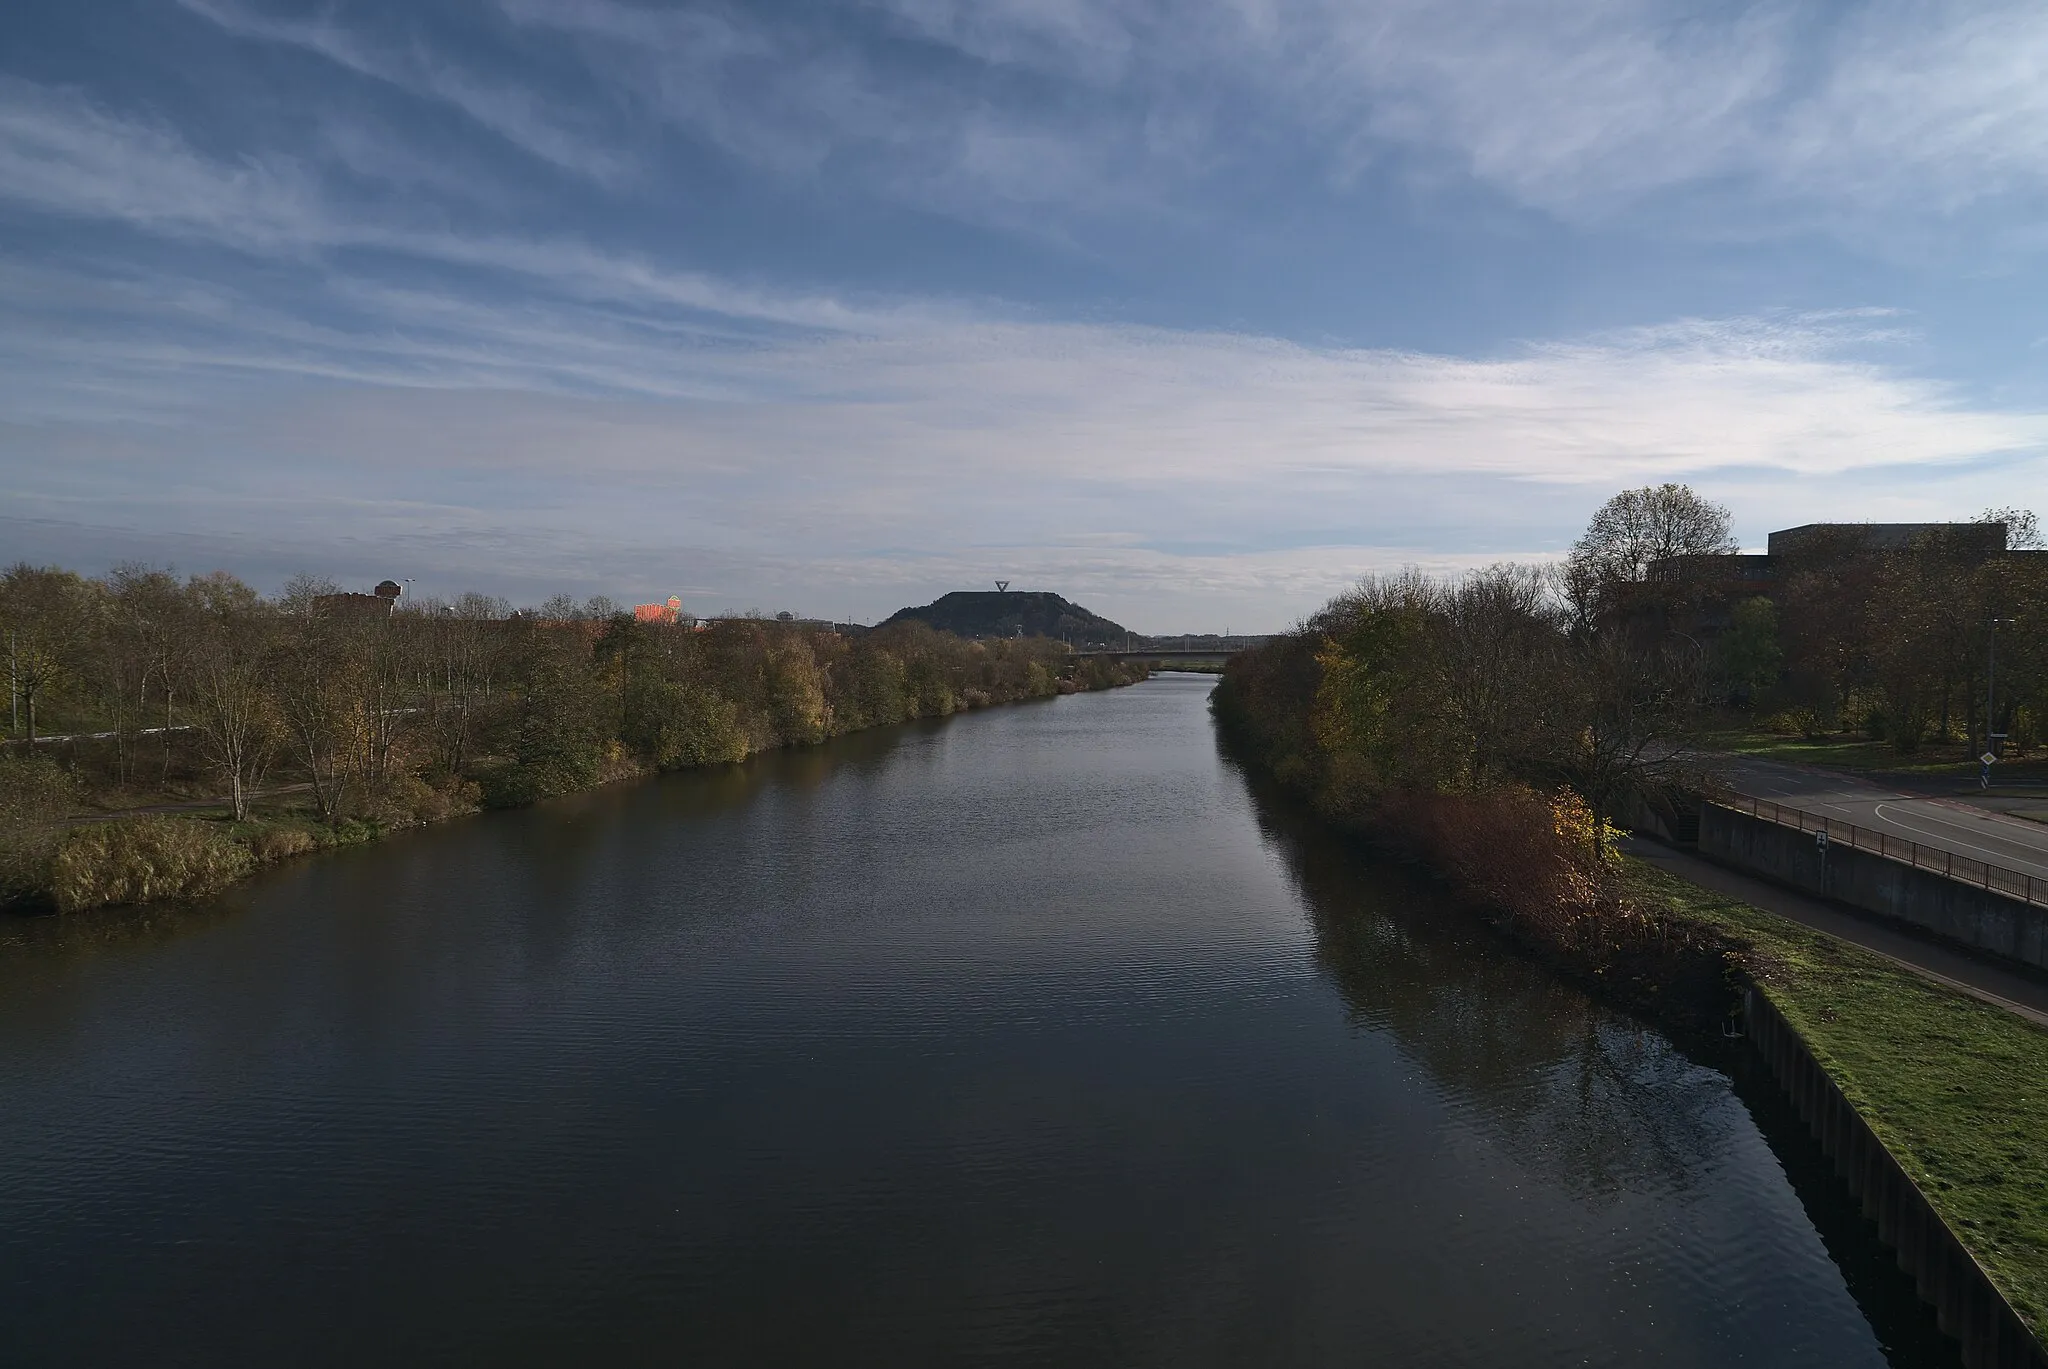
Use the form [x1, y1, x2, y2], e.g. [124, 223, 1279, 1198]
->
[0, 0, 2048, 631]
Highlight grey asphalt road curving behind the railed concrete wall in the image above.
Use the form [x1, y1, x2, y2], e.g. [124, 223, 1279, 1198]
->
[1706, 754, 2048, 879]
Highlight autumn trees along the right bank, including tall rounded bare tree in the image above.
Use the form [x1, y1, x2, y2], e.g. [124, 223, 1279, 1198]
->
[1214, 486, 2048, 959]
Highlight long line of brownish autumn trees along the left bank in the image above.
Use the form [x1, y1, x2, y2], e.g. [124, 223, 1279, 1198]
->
[0, 564, 1143, 914]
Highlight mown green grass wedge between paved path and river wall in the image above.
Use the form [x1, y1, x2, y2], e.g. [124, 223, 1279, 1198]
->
[1628, 861, 2048, 1336]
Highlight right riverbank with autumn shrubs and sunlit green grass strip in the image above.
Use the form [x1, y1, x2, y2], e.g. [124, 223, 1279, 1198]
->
[1214, 635, 2048, 1340]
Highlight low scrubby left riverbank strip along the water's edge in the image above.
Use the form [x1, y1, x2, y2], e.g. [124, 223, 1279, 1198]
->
[0, 644, 1147, 914]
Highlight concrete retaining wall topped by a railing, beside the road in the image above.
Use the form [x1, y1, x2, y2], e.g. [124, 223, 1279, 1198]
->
[1700, 803, 2048, 969]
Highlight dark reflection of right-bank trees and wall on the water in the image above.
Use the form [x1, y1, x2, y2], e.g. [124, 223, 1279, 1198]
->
[1225, 748, 1962, 1369]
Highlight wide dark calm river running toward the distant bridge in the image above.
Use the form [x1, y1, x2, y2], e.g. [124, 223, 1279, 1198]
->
[0, 676, 1954, 1369]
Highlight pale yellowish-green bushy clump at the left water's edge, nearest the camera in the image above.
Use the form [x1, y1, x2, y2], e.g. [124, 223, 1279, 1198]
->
[49, 818, 254, 912]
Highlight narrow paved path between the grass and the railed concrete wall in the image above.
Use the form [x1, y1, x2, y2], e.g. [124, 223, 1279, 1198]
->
[1622, 836, 2048, 1027]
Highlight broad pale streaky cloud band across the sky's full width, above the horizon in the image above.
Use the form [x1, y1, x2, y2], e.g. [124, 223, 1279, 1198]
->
[0, 73, 2048, 610]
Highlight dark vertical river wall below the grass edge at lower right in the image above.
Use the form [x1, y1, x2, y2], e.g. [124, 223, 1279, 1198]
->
[1743, 987, 2048, 1369]
